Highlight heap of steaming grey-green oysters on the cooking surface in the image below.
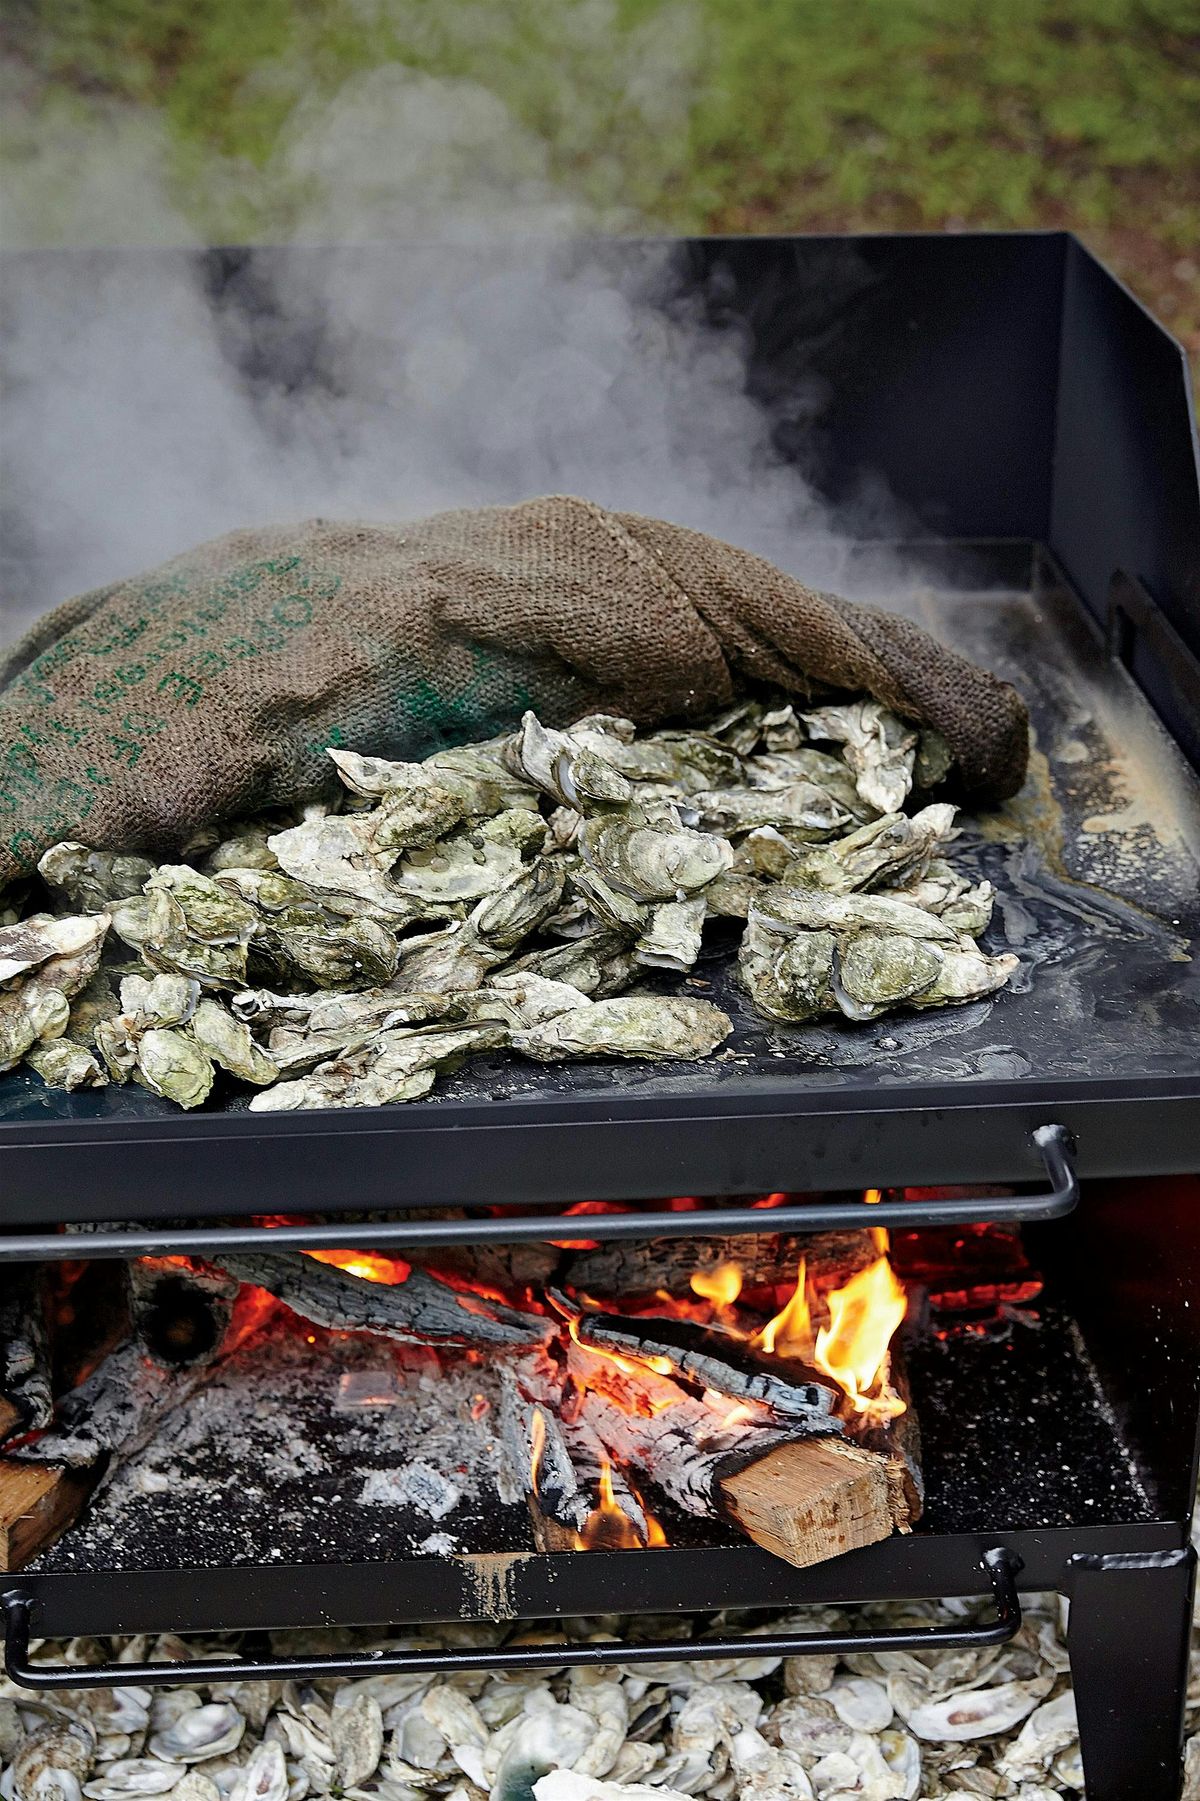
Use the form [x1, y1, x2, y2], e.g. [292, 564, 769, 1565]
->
[0, 699, 1016, 1109]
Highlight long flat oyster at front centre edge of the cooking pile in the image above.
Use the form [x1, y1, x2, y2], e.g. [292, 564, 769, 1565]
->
[512, 994, 733, 1063]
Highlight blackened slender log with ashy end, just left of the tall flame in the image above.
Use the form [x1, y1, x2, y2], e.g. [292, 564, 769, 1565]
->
[548, 1290, 841, 1434]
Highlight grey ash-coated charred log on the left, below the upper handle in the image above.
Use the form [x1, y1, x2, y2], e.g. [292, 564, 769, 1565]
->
[211, 1252, 555, 1347]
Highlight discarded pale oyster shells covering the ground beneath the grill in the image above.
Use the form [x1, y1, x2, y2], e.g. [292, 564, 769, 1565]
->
[0, 1596, 1153, 1801]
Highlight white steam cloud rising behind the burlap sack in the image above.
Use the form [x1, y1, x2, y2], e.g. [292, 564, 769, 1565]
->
[0, 33, 893, 639]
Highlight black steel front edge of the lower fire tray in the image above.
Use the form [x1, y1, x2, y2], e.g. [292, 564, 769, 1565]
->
[9, 1520, 1187, 1639]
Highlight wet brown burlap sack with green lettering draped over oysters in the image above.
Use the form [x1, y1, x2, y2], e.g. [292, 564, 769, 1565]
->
[0, 497, 1027, 884]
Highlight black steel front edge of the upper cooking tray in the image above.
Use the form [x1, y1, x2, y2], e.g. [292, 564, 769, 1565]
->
[0, 1084, 1200, 1237]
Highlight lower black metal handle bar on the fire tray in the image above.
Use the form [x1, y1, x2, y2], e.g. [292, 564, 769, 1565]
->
[4, 1549, 1022, 1689]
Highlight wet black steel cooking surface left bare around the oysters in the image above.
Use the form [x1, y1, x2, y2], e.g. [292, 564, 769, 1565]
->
[0, 544, 1200, 1122]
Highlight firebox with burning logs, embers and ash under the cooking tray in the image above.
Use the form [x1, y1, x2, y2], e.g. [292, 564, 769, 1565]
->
[5, 1190, 1157, 1617]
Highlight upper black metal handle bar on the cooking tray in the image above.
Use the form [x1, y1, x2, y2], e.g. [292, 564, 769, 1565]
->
[0, 1126, 1079, 1264]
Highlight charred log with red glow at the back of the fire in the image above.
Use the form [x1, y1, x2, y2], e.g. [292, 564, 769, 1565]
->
[560, 1232, 879, 1302]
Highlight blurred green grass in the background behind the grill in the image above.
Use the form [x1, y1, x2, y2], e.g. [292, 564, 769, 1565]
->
[5, 0, 1200, 346]
